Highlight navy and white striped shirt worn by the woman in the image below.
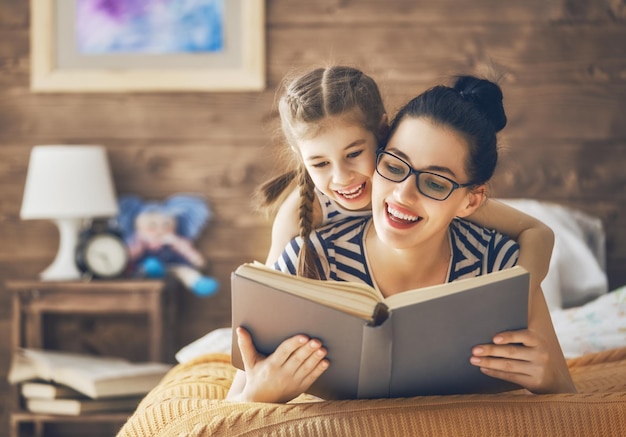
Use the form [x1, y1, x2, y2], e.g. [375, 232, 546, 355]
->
[274, 217, 519, 287]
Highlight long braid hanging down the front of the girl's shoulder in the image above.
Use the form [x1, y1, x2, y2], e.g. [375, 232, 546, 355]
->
[298, 168, 320, 279]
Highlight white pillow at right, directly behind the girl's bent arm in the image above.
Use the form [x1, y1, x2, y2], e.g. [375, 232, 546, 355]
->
[498, 199, 608, 310]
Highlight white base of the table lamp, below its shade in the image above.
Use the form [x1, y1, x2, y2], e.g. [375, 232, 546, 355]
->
[39, 218, 82, 281]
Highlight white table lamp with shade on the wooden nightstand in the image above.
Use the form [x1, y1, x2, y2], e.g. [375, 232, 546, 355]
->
[20, 145, 118, 281]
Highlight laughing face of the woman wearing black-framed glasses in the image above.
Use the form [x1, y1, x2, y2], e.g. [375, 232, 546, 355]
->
[372, 118, 483, 249]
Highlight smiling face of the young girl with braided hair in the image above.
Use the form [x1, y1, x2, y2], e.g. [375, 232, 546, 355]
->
[298, 119, 378, 211]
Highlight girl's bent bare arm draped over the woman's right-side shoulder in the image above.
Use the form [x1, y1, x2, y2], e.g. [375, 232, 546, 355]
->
[466, 199, 554, 290]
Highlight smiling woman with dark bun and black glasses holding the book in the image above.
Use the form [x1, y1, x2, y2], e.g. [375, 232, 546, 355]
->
[228, 76, 575, 402]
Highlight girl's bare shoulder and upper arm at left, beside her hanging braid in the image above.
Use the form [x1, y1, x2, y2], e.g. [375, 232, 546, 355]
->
[265, 189, 322, 267]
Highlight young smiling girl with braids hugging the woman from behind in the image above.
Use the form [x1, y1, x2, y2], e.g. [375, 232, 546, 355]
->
[260, 66, 554, 287]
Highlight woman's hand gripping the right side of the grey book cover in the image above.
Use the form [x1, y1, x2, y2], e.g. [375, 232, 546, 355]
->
[470, 329, 571, 394]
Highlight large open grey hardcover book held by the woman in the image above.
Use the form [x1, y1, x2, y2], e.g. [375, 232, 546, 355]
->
[231, 263, 529, 399]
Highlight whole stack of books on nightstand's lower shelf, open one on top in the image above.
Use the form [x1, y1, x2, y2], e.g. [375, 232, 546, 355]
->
[8, 349, 171, 415]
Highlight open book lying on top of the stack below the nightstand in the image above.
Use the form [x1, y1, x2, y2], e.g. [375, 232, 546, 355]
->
[8, 348, 172, 399]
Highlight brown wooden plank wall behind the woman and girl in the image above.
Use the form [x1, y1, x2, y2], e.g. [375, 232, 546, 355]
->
[0, 0, 626, 433]
